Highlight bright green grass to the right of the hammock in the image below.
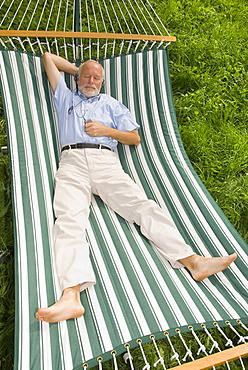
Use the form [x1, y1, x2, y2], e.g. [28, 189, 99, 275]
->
[159, 0, 248, 241]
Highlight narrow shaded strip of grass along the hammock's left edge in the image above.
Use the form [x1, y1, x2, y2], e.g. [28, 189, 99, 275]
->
[0, 102, 15, 369]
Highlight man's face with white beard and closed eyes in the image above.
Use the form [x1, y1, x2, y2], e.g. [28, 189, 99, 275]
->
[78, 61, 103, 98]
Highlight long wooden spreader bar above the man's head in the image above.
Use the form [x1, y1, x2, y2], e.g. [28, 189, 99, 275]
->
[0, 30, 176, 42]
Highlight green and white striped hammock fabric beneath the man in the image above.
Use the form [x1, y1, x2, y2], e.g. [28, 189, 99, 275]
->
[0, 50, 248, 370]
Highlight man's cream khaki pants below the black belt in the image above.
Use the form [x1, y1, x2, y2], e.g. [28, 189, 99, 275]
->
[54, 149, 194, 290]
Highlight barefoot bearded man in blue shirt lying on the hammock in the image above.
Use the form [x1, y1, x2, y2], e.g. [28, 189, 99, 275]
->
[36, 53, 237, 322]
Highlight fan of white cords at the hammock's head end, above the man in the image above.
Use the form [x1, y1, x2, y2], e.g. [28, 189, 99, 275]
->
[0, 0, 170, 60]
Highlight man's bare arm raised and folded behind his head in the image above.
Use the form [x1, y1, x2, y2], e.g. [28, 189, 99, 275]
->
[43, 52, 78, 92]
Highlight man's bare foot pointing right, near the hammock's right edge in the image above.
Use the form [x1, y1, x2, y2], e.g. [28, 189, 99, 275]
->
[180, 253, 237, 281]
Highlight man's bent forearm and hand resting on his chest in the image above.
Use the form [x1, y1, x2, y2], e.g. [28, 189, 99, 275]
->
[84, 121, 140, 145]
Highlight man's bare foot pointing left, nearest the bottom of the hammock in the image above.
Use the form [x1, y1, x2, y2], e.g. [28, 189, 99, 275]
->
[35, 285, 84, 323]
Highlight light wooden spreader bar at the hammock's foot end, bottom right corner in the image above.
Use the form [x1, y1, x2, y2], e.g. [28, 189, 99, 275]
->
[173, 343, 248, 370]
